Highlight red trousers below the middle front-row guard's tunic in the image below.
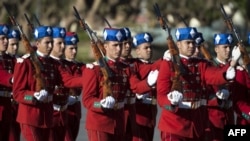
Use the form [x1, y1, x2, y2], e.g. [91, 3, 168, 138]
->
[87, 130, 124, 141]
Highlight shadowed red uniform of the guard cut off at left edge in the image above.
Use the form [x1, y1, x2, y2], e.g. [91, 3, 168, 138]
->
[0, 54, 15, 140]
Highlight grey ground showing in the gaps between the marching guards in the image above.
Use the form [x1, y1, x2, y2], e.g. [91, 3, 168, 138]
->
[77, 107, 160, 141]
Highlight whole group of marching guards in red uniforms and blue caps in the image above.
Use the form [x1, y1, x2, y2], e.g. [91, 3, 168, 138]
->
[0, 19, 250, 141]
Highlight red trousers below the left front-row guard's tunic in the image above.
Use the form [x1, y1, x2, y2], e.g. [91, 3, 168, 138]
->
[20, 124, 50, 141]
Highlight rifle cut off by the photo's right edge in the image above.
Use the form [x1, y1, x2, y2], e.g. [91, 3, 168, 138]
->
[220, 3, 250, 74]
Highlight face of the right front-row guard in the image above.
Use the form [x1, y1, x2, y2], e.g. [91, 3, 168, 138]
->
[176, 40, 196, 57]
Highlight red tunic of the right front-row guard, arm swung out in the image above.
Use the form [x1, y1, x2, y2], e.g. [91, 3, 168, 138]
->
[157, 58, 229, 140]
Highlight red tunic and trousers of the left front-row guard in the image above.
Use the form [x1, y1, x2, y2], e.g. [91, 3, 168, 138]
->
[13, 55, 57, 140]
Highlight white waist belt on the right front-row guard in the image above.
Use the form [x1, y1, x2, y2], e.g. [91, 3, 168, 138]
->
[179, 99, 207, 109]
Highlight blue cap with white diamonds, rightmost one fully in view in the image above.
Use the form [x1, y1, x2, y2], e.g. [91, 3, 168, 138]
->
[214, 33, 233, 45]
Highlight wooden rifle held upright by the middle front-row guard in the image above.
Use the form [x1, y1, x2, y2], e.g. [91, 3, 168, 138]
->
[73, 6, 112, 97]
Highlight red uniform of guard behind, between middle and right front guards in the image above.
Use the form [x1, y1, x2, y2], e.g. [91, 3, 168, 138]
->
[133, 59, 162, 141]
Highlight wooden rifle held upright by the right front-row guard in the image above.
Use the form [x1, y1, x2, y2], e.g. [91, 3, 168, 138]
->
[154, 3, 185, 92]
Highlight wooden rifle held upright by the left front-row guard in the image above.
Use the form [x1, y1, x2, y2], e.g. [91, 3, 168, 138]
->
[3, 4, 45, 91]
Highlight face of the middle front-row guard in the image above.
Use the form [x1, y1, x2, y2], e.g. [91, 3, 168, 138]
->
[104, 41, 122, 60]
